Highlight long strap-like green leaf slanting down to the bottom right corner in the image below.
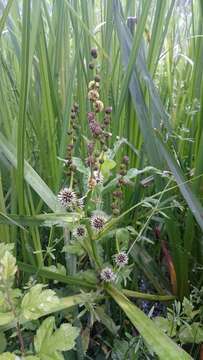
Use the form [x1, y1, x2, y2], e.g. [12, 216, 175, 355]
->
[106, 286, 192, 360]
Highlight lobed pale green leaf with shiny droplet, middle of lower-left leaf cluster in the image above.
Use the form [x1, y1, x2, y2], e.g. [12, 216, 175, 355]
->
[21, 284, 60, 320]
